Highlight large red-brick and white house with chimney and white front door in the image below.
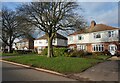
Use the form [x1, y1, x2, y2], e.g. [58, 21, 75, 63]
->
[68, 21, 120, 52]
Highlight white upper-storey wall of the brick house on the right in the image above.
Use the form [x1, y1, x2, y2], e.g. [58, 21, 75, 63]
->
[68, 30, 119, 44]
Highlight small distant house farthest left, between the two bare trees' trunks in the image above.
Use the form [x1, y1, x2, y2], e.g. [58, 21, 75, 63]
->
[16, 38, 34, 50]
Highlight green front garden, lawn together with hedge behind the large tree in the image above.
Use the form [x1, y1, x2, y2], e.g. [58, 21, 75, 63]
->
[3, 48, 110, 74]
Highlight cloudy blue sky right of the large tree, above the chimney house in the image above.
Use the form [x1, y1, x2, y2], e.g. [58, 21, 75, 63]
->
[81, 2, 118, 27]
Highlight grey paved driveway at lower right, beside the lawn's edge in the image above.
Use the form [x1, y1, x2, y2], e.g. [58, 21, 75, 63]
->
[74, 61, 120, 81]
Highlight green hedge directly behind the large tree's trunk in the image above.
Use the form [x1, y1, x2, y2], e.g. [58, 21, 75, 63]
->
[41, 47, 67, 56]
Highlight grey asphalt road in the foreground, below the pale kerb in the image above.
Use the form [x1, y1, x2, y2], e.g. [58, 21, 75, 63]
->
[2, 62, 75, 81]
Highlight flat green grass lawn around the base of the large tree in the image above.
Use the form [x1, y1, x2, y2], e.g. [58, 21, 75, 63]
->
[5, 55, 104, 74]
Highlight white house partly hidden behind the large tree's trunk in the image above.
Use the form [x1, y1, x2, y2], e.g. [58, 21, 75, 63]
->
[34, 33, 67, 53]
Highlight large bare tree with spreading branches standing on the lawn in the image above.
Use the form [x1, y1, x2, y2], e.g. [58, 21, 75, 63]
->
[19, 2, 84, 57]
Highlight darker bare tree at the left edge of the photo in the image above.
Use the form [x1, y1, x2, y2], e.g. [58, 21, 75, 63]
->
[0, 7, 33, 53]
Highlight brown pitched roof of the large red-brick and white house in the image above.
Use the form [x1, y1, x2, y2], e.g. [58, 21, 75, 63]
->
[68, 24, 119, 36]
